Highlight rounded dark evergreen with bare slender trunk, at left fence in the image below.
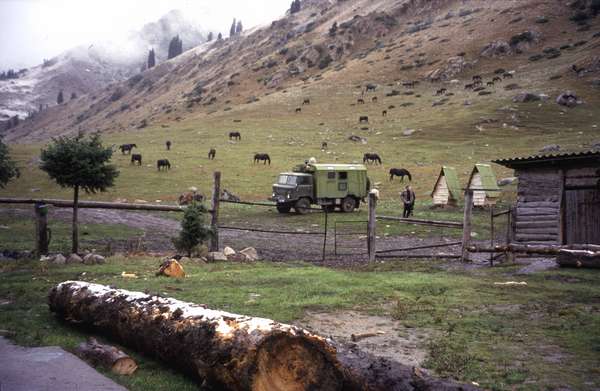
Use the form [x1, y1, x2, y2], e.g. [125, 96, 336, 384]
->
[40, 133, 119, 253]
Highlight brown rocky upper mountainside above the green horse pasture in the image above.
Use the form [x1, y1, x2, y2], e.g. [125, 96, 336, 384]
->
[2, 0, 600, 142]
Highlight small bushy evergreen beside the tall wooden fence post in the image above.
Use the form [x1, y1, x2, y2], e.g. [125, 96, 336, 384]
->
[173, 201, 212, 257]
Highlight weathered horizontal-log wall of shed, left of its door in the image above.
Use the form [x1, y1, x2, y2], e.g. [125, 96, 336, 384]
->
[514, 168, 563, 244]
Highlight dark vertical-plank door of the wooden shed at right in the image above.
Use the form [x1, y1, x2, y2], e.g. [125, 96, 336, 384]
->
[564, 188, 600, 245]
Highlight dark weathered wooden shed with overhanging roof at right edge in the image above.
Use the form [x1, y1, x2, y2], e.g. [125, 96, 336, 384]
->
[494, 151, 600, 245]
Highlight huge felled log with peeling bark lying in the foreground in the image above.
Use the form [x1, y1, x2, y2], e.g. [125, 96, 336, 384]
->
[48, 281, 476, 391]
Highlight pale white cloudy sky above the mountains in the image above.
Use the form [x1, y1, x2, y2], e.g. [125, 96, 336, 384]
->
[0, 0, 289, 69]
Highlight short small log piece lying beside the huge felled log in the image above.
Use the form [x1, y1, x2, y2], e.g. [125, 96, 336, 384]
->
[75, 338, 137, 375]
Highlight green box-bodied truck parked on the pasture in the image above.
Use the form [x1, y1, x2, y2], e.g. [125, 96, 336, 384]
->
[269, 163, 371, 214]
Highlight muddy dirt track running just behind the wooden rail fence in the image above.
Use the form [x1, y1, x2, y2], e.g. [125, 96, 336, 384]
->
[0, 208, 492, 266]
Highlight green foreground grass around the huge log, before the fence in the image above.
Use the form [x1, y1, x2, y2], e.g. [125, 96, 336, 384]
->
[0, 258, 600, 391]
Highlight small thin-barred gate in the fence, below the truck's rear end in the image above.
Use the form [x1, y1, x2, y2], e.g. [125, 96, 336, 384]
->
[333, 220, 368, 256]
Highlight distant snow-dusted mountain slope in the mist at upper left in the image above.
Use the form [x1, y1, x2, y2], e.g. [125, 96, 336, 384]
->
[0, 10, 206, 122]
